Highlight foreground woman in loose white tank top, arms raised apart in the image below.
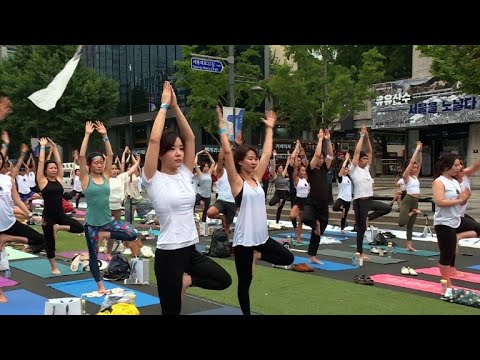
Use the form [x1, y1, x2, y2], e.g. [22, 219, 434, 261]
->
[217, 106, 294, 315]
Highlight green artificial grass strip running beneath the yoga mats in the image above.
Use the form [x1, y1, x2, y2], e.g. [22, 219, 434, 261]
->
[42, 227, 480, 315]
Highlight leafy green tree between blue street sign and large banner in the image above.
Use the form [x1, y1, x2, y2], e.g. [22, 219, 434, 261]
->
[267, 45, 384, 137]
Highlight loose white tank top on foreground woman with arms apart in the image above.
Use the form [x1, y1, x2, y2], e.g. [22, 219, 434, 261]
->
[233, 181, 268, 247]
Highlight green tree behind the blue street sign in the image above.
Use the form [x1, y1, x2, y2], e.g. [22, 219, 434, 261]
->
[175, 45, 265, 142]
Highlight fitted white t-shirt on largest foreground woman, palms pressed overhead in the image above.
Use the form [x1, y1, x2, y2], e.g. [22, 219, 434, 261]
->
[142, 164, 198, 250]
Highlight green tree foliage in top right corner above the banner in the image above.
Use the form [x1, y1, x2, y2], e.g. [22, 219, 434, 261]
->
[418, 45, 480, 95]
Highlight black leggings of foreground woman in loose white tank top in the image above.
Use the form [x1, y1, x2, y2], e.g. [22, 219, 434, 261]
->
[234, 238, 294, 315]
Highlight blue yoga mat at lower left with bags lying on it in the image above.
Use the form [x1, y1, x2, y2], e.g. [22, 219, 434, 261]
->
[47, 279, 160, 307]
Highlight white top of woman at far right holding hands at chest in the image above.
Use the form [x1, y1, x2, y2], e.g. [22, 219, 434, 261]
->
[433, 175, 461, 229]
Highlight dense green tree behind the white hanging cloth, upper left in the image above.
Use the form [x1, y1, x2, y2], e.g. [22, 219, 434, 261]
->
[0, 45, 120, 158]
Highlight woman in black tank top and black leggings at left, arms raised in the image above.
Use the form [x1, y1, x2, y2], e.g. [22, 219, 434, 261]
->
[37, 138, 83, 275]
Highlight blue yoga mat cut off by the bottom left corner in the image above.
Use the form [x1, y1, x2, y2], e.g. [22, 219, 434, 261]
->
[0, 289, 48, 315]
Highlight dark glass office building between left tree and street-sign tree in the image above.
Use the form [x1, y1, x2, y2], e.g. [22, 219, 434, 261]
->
[84, 45, 185, 153]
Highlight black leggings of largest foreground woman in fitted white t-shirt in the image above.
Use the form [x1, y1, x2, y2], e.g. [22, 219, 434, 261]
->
[155, 245, 232, 315]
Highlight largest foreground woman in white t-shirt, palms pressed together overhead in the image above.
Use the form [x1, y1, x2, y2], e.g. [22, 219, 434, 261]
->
[142, 81, 232, 315]
